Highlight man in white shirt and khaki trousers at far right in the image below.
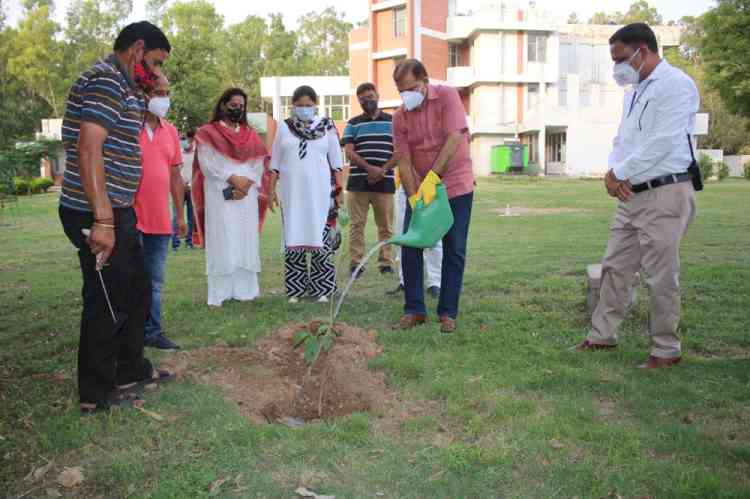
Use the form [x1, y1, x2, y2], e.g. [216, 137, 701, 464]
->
[576, 23, 700, 369]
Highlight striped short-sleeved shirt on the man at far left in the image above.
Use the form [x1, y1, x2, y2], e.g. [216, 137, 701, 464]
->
[60, 55, 144, 211]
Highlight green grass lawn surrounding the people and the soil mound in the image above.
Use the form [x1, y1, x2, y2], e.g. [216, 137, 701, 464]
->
[0, 179, 750, 499]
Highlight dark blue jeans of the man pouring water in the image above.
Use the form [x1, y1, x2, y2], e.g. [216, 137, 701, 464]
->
[401, 192, 474, 319]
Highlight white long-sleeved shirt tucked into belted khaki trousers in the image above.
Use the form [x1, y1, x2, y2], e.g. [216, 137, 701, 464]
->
[609, 60, 700, 185]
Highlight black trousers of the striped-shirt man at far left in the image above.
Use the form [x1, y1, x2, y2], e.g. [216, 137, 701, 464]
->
[60, 207, 152, 403]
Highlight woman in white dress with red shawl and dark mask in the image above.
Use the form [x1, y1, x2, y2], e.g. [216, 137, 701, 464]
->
[194, 89, 267, 306]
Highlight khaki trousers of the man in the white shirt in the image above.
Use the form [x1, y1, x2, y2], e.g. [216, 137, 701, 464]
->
[588, 182, 695, 358]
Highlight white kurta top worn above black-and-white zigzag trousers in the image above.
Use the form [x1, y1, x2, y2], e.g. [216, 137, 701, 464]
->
[270, 122, 343, 249]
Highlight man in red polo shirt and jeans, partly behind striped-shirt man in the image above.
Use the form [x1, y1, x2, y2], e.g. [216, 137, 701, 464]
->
[135, 73, 187, 350]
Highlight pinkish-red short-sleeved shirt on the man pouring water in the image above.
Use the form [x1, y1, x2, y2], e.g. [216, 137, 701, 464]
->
[393, 85, 474, 198]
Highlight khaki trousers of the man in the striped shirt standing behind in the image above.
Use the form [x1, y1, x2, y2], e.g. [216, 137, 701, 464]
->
[347, 191, 393, 267]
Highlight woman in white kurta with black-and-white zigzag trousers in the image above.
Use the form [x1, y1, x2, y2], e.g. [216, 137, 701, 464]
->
[271, 86, 343, 303]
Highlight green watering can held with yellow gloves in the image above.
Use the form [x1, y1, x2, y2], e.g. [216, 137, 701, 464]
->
[388, 184, 453, 248]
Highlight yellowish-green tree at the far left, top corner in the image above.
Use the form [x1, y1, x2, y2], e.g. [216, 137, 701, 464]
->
[8, 5, 68, 117]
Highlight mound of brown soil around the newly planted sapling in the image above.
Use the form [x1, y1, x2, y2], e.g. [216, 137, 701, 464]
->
[189, 321, 394, 422]
